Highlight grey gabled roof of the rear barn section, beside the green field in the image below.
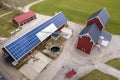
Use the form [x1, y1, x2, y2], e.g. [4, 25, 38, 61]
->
[88, 8, 110, 28]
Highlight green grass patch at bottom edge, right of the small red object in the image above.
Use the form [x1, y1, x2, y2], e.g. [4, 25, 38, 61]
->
[78, 70, 117, 80]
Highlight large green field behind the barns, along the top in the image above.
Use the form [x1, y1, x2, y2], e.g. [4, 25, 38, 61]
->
[30, 0, 120, 34]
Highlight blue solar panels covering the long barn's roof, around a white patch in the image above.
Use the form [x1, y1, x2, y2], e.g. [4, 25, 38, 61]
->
[4, 13, 67, 61]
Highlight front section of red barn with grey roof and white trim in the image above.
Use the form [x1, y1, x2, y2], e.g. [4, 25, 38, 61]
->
[77, 23, 101, 54]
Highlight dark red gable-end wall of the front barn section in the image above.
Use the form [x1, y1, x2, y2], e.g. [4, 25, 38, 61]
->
[77, 36, 93, 54]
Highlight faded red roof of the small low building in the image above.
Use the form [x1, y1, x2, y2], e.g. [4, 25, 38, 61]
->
[13, 11, 35, 23]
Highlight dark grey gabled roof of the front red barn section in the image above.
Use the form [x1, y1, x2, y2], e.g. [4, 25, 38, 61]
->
[80, 23, 101, 43]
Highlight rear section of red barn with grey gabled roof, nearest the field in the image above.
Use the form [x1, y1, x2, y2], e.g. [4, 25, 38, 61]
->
[87, 8, 110, 30]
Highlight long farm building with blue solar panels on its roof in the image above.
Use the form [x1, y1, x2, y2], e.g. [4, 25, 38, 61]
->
[3, 12, 67, 65]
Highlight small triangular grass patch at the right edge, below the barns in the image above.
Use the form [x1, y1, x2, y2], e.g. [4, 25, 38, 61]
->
[106, 58, 120, 70]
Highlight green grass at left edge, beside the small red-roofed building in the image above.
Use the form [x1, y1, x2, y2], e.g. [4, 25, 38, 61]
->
[0, 13, 17, 37]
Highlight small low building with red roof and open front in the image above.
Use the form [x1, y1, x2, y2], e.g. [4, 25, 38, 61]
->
[12, 11, 36, 26]
